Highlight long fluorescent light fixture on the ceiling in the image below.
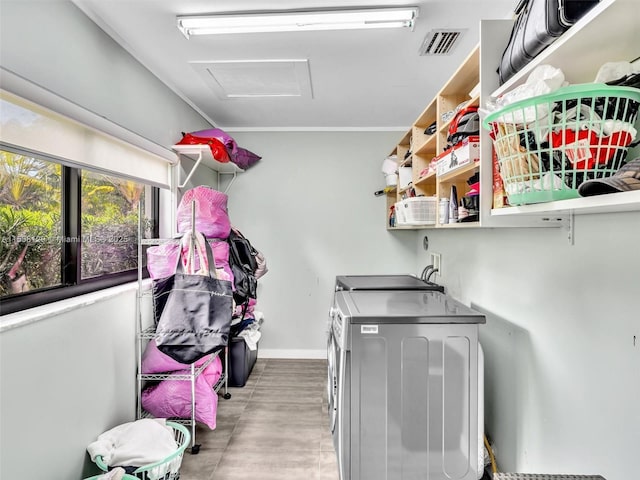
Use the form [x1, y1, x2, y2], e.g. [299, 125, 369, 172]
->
[177, 7, 418, 38]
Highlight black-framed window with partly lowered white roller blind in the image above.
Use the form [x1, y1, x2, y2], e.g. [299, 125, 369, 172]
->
[0, 88, 170, 315]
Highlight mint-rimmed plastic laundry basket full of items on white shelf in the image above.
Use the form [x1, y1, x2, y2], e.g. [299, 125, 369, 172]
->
[483, 83, 640, 205]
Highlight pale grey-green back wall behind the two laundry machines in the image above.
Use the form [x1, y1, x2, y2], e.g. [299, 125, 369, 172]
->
[222, 132, 415, 358]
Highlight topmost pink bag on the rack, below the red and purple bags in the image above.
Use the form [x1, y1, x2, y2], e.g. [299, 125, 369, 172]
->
[177, 185, 231, 239]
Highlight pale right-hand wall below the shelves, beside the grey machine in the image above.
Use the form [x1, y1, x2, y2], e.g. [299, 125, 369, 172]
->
[416, 212, 640, 480]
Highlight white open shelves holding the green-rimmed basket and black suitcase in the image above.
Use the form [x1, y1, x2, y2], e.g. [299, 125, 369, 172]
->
[480, 0, 640, 223]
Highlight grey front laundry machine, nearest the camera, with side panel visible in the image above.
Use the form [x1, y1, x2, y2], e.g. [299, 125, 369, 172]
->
[328, 291, 485, 480]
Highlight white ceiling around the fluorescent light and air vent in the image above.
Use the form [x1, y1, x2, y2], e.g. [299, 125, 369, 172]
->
[72, 0, 517, 130]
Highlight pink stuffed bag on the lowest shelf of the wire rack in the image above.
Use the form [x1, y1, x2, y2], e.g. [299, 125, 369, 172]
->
[141, 357, 222, 430]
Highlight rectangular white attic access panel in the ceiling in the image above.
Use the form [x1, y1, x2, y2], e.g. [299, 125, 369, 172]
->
[190, 59, 313, 99]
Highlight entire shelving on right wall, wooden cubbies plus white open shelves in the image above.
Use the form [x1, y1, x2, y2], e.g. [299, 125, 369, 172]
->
[385, 0, 640, 230]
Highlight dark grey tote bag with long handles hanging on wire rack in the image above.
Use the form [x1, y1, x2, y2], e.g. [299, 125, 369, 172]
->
[155, 233, 233, 364]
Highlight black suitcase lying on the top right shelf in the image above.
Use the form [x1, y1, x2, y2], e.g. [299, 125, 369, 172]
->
[498, 0, 599, 84]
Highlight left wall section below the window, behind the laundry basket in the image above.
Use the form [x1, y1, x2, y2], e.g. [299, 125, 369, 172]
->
[0, 287, 136, 480]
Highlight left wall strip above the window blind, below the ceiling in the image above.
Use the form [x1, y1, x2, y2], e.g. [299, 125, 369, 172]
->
[0, 0, 209, 148]
